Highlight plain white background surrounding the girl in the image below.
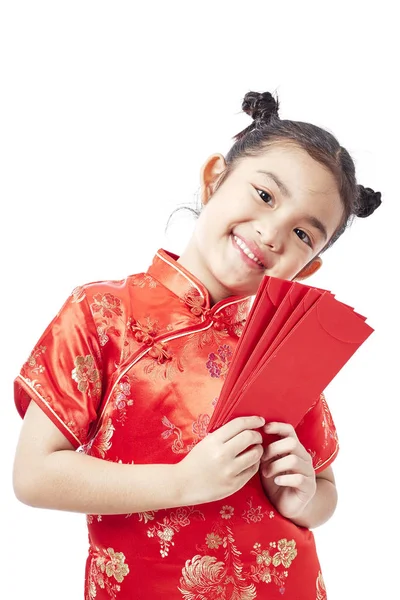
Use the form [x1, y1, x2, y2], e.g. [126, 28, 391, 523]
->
[0, 0, 400, 600]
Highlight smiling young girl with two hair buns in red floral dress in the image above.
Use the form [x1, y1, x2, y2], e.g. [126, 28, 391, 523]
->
[14, 92, 380, 600]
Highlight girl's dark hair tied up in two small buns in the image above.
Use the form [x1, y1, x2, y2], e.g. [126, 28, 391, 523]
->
[167, 92, 381, 250]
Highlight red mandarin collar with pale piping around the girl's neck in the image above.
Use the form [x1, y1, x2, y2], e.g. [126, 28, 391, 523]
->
[147, 248, 252, 314]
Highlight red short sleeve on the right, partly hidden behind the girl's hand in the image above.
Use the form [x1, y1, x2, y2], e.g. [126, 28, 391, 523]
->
[296, 394, 339, 473]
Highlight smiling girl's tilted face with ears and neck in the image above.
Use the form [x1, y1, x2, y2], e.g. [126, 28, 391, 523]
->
[179, 144, 343, 303]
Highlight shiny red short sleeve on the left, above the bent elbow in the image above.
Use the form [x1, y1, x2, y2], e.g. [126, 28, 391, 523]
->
[14, 288, 102, 448]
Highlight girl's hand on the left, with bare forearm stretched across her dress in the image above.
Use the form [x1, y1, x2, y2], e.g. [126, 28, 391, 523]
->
[176, 417, 265, 505]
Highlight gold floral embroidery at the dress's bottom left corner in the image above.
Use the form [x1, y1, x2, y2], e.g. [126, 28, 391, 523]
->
[85, 546, 129, 600]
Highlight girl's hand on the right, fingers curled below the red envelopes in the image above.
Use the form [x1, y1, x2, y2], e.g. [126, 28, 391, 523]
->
[260, 423, 317, 519]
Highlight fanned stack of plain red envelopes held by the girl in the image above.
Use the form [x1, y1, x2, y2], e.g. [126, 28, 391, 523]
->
[209, 276, 373, 431]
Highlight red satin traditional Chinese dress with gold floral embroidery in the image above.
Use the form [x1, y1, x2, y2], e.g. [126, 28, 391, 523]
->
[15, 249, 338, 600]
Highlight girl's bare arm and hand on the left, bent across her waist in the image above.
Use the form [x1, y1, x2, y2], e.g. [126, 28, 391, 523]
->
[13, 401, 264, 514]
